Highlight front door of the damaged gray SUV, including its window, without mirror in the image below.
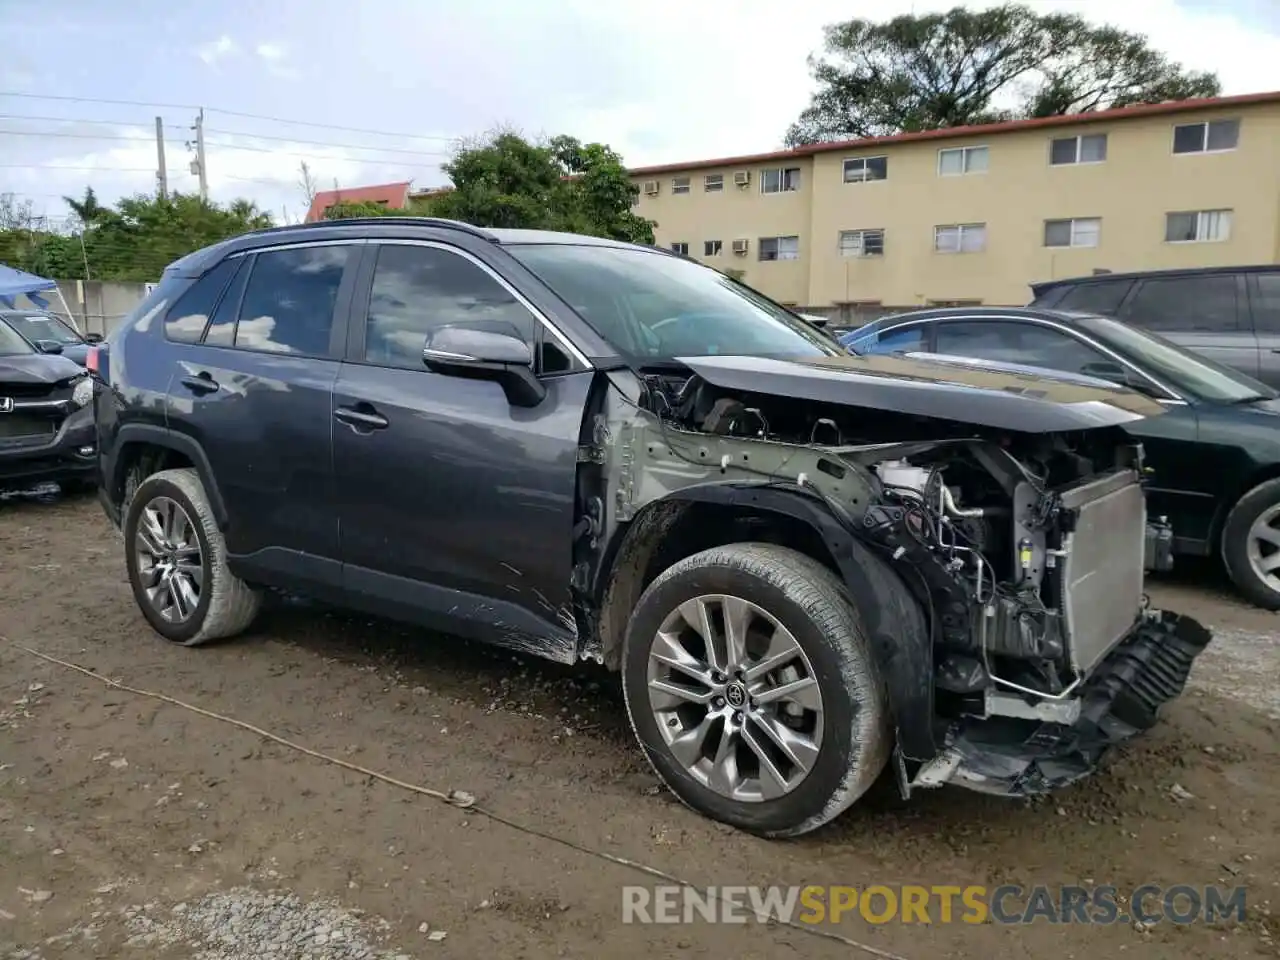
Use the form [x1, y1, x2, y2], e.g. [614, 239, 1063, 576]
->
[334, 241, 593, 659]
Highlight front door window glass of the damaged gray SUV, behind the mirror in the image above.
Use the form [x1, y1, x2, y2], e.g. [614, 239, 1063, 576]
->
[365, 243, 537, 370]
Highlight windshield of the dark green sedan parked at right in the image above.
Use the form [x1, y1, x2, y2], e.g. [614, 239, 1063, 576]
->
[1079, 316, 1276, 403]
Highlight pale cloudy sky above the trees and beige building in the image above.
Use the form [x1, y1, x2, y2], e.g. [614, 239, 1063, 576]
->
[0, 0, 1280, 226]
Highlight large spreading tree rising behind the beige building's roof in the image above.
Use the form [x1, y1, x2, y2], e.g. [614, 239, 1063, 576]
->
[786, 4, 1220, 146]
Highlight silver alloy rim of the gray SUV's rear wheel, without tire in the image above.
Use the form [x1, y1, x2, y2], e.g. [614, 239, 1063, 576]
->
[133, 497, 205, 623]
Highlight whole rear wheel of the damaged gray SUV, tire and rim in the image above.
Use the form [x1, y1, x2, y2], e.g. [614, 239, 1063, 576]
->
[123, 468, 261, 646]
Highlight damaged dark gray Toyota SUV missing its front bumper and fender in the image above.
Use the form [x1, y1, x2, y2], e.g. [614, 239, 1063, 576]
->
[90, 218, 1210, 836]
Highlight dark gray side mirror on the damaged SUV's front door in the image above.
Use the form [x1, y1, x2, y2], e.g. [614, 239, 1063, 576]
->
[422, 323, 547, 407]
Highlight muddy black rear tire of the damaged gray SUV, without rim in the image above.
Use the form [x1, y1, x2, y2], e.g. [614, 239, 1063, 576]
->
[122, 468, 262, 646]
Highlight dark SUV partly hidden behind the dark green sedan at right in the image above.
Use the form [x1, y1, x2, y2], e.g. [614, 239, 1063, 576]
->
[1030, 264, 1280, 389]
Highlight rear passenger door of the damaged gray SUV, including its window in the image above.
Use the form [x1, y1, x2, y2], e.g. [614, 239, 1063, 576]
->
[169, 241, 361, 586]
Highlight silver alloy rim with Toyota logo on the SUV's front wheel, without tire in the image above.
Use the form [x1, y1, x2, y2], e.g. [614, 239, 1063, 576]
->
[648, 594, 823, 803]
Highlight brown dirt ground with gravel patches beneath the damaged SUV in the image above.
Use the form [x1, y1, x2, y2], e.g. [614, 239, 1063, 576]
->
[0, 499, 1280, 960]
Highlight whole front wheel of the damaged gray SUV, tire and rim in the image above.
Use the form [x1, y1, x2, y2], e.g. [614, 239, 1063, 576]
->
[622, 544, 891, 837]
